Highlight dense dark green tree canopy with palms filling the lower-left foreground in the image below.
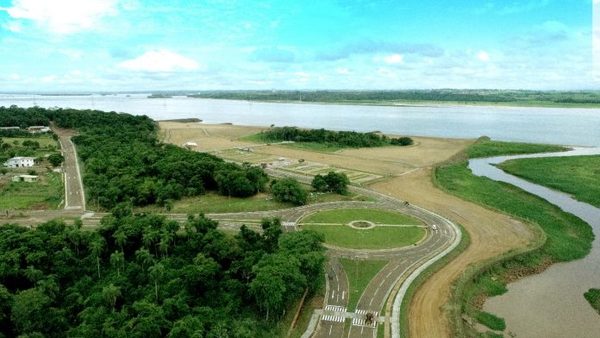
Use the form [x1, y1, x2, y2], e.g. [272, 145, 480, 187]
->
[0, 213, 325, 338]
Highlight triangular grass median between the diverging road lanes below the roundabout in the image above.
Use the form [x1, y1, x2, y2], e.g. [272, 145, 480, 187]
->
[340, 258, 388, 311]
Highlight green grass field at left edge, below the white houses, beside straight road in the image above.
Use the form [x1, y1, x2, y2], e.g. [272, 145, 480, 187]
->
[0, 173, 64, 211]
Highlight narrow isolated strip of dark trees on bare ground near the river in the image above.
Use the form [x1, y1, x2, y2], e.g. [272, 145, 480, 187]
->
[260, 127, 413, 148]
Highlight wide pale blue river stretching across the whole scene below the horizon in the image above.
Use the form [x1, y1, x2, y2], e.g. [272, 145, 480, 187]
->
[0, 94, 600, 146]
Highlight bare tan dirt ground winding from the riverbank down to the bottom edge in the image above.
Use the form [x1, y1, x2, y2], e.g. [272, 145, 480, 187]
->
[160, 122, 534, 337]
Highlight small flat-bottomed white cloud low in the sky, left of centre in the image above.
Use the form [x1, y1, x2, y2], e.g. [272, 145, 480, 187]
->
[119, 49, 200, 73]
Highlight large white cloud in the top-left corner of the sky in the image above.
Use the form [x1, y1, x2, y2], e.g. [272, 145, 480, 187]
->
[0, 0, 118, 34]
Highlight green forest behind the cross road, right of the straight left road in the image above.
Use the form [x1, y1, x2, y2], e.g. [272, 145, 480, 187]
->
[0, 106, 268, 210]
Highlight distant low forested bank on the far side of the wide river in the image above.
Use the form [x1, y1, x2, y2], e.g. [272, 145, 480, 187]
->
[188, 89, 600, 106]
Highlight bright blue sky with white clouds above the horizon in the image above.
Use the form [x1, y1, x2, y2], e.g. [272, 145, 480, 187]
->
[0, 0, 600, 92]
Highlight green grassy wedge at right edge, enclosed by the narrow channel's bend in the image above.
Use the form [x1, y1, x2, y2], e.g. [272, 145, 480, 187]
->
[499, 156, 600, 207]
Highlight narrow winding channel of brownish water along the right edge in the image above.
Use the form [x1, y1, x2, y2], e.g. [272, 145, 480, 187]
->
[469, 148, 600, 338]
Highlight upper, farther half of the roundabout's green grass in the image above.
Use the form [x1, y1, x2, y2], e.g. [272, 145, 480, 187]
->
[302, 209, 423, 225]
